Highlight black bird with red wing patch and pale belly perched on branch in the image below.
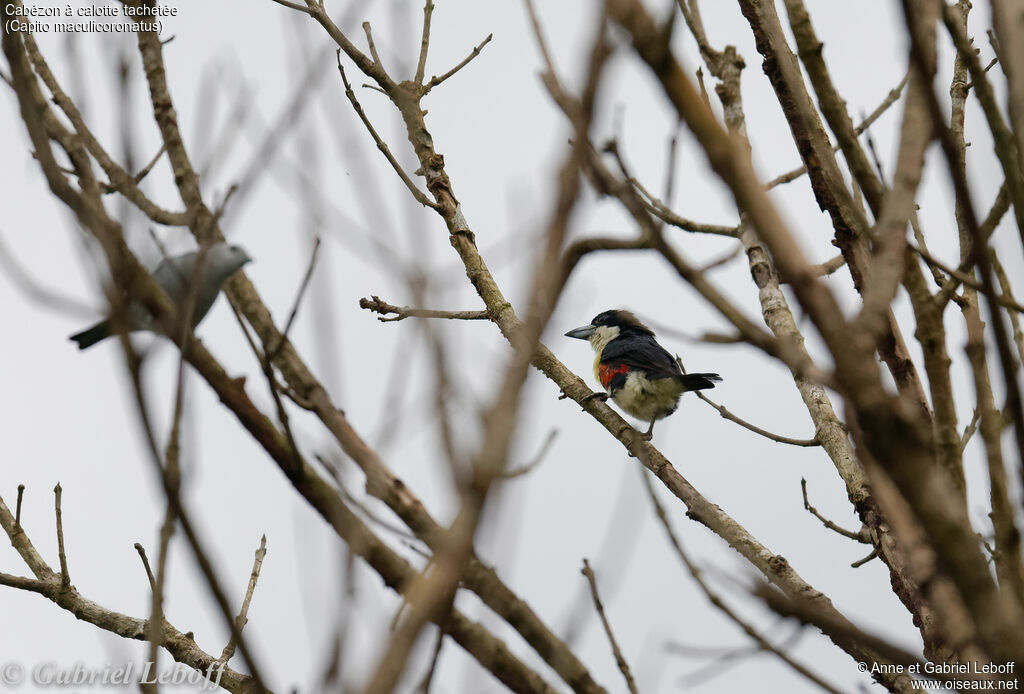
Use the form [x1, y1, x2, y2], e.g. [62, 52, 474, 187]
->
[565, 311, 722, 441]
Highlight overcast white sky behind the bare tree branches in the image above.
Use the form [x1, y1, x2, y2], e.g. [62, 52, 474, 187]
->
[0, 0, 1024, 694]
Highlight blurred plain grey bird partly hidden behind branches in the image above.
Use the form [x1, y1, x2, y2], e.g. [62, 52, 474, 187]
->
[70, 242, 252, 350]
